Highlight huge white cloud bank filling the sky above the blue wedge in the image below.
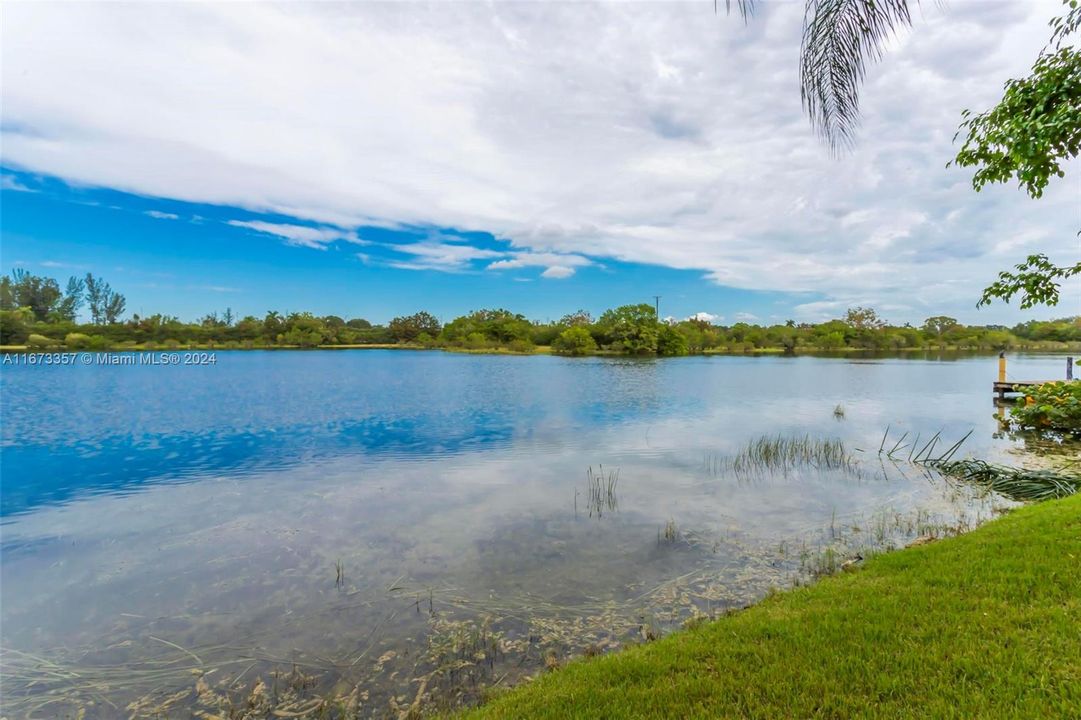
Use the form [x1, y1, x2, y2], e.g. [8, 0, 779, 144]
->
[0, 0, 1081, 319]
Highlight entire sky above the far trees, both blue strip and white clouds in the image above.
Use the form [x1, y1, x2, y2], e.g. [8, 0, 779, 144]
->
[0, 0, 1081, 324]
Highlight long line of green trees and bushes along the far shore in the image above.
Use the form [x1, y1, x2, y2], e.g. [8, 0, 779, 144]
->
[0, 269, 1081, 356]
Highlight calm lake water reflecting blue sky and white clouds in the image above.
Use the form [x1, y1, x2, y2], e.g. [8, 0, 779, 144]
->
[0, 350, 1065, 717]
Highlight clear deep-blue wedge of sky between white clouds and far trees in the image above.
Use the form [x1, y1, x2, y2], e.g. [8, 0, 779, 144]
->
[0, 169, 795, 322]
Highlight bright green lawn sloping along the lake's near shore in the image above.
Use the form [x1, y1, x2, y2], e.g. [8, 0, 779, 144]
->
[464, 495, 1081, 719]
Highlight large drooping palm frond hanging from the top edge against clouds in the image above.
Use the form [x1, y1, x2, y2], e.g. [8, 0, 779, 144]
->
[799, 0, 918, 151]
